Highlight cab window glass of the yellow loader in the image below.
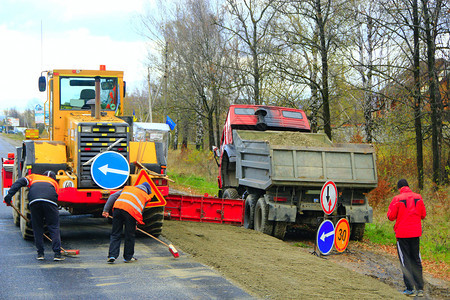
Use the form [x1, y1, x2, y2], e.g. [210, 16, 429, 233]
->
[60, 77, 118, 110]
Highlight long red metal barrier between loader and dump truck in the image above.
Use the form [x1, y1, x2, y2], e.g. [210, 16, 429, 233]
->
[164, 194, 244, 225]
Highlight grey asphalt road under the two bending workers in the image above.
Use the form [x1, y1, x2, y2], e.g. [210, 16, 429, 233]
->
[0, 135, 252, 299]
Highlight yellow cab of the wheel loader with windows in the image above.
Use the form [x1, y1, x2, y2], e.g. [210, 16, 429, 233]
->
[39, 66, 126, 143]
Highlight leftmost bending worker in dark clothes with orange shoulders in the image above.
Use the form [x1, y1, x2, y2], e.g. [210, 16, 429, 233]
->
[4, 171, 64, 261]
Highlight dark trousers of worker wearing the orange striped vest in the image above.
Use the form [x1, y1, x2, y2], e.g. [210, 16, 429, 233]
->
[108, 208, 136, 260]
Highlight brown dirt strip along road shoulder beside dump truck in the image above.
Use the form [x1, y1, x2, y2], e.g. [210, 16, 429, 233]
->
[163, 220, 449, 299]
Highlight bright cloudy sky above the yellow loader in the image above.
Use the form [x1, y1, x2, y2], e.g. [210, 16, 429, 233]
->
[0, 0, 155, 115]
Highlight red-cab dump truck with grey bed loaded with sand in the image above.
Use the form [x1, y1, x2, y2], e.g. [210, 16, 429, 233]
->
[213, 105, 377, 240]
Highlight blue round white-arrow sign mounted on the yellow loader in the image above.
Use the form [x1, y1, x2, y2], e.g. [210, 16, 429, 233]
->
[91, 151, 130, 190]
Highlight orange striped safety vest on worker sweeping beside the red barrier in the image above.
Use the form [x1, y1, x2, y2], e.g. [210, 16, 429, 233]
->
[113, 186, 151, 224]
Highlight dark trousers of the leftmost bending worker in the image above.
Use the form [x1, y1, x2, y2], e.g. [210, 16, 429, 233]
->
[30, 201, 61, 254]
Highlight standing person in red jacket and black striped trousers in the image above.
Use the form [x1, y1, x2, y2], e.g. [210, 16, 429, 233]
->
[387, 179, 427, 297]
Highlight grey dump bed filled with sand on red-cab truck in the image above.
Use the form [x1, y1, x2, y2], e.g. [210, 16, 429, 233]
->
[233, 130, 377, 190]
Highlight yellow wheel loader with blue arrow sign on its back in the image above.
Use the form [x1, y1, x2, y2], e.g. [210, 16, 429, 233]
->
[2, 65, 169, 239]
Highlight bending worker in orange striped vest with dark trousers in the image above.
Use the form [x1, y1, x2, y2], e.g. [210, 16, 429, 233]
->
[102, 182, 152, 263]
